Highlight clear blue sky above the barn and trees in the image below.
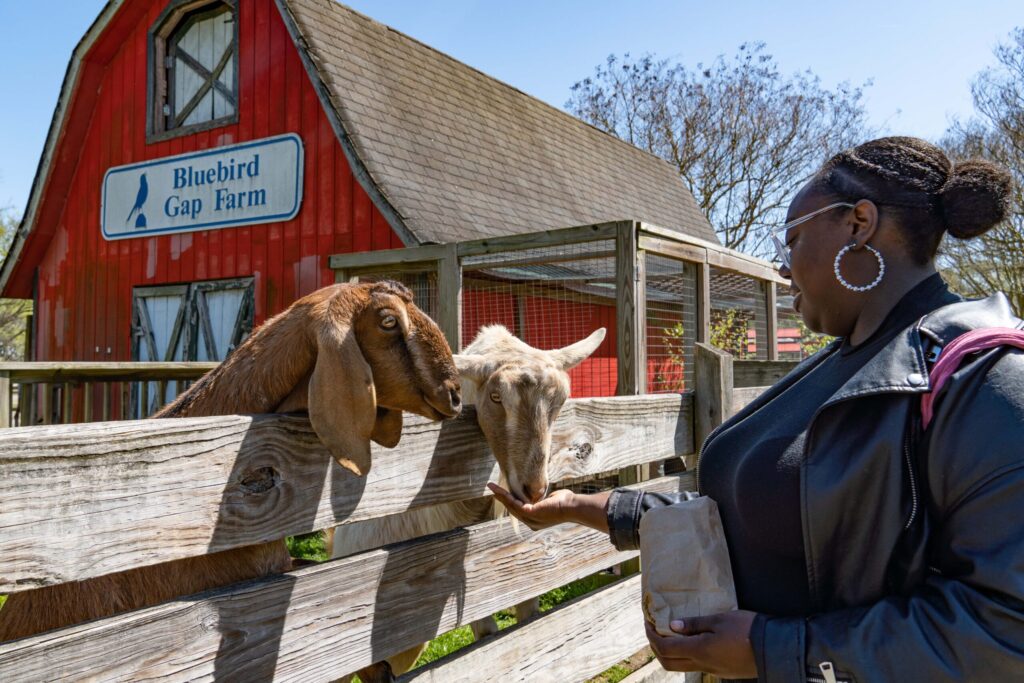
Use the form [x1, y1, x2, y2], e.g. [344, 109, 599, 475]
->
[0, 0, 1024, 219]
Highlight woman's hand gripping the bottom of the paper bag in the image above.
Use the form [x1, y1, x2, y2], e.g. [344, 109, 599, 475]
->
[644, 610, 758, 678]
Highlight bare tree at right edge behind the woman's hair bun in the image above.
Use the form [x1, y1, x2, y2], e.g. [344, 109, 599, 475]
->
[939, 28, 1024, 311]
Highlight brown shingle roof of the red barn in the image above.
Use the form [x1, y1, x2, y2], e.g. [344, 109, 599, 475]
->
[279, 0, 719, 244]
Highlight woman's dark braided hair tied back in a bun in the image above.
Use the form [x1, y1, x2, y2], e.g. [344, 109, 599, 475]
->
[811, 137, 1012, 264]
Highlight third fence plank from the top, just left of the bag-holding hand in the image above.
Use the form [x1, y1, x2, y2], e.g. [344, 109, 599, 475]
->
[398, 575, 647, 683]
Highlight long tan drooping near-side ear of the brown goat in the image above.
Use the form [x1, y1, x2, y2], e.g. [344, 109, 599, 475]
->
[308, 327, 377, 476]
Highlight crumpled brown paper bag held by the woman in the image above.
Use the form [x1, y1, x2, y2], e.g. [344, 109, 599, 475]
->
[640, 497, 736, 636]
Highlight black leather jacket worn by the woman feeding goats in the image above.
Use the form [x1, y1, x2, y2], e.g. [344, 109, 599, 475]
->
[608, 294, 1024, 683]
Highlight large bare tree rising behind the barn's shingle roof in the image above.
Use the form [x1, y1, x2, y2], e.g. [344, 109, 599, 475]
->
[565, 43, 869, 255]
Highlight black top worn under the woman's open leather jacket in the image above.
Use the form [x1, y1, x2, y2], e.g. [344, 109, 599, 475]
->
[700, 274, 958, 616]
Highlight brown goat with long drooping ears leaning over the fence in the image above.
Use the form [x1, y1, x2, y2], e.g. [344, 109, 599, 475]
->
[0, 282, 461, 641]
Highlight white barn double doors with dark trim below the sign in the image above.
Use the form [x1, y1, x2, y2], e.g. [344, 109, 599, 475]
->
[129, 278, 254, 419]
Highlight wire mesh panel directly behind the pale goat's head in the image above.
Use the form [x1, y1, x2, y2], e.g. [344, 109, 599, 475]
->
[462, 240, 617, 397]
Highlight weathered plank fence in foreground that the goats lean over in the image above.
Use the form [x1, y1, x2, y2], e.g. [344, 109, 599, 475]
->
[0, 345, 798, 682]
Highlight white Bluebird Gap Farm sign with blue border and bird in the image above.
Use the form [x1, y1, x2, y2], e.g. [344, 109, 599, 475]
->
[99, 134, 302, 240]
